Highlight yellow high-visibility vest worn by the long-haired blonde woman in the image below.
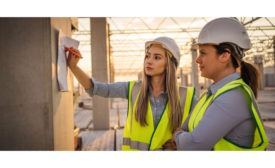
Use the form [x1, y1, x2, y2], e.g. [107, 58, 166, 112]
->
[122, 81, 195, 150]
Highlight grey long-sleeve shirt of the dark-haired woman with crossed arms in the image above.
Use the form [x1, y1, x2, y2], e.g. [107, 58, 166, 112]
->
[175, 73, 255, 150]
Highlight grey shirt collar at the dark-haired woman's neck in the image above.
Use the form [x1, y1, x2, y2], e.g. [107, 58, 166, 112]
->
[208, 72, 240, 94]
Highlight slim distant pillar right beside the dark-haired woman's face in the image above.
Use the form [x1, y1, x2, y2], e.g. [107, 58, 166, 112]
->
[191, 39, 200, 97]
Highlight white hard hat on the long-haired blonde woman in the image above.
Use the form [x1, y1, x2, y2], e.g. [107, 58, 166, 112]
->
[145, 37, 180, 66]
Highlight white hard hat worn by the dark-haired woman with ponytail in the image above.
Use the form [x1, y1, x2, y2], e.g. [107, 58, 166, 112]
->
[198, 18, 251, 50]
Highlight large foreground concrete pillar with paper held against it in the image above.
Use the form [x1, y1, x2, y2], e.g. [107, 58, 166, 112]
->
[0, 18, 74, 150]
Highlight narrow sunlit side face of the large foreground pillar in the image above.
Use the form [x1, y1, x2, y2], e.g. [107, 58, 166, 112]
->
[51, 18, 74, 150]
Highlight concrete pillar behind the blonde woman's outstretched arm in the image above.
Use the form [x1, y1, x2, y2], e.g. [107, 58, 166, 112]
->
[90, 18, 110, 130]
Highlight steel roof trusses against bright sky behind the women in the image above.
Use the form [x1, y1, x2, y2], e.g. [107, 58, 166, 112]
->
[74, 17, 275, 81]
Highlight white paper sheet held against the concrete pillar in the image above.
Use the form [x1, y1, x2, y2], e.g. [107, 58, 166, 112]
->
[57, 31, 79, 92]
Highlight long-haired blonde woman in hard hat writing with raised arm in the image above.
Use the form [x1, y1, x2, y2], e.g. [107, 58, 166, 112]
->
[65, 37, 195, 150]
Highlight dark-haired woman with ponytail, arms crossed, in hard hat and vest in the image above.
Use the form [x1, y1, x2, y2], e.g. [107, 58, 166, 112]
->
[164, 18, 268, 150]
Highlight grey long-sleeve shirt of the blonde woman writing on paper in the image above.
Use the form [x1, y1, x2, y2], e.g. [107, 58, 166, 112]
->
[86, 78, 168, 127]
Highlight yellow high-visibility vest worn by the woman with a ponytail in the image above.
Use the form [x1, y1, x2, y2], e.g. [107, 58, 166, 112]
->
[188, 78, 268, 150]
